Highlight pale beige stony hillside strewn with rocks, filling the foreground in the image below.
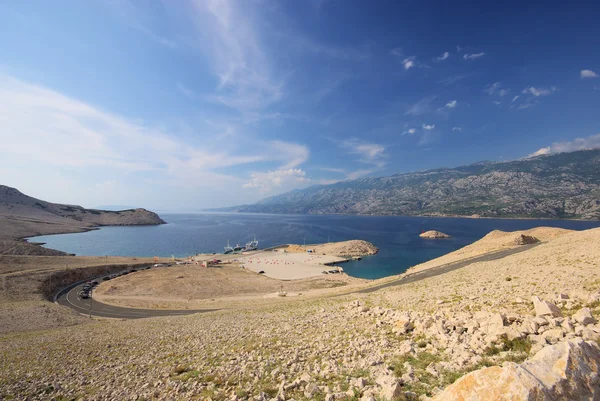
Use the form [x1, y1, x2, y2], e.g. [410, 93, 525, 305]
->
[0, 228, 600, 401]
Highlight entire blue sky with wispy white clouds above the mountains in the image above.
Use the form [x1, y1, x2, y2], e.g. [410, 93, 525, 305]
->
[0, 0, 600, 211]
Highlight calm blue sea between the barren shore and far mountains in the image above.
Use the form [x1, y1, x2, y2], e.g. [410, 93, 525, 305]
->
[34, 214, 600, 279]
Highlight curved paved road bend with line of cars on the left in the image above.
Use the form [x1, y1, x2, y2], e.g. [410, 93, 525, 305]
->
[56, 284, 218, 319]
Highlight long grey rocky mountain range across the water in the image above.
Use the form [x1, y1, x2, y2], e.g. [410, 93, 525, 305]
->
[211, 149, 600, 220]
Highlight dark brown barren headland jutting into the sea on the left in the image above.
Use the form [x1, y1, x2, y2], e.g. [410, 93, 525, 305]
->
[0, 185, 165, 256]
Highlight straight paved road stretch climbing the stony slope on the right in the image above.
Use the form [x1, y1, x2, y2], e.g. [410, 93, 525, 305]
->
[339, 243, 539, 296]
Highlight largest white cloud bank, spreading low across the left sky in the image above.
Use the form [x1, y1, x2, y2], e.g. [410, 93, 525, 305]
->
[0, 74, 310, 207]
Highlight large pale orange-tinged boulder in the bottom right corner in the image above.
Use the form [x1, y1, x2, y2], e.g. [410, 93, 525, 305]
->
[434, 338, 600, 401]
